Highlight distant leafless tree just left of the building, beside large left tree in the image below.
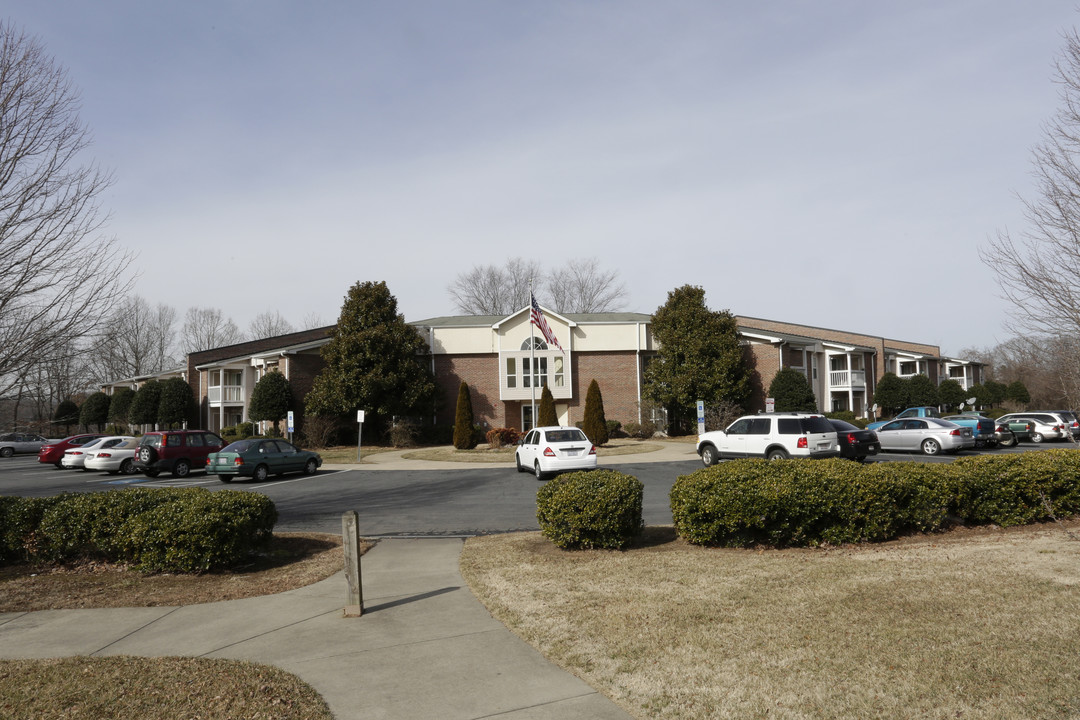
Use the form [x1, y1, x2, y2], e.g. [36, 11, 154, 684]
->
[94, 295, 176, 382]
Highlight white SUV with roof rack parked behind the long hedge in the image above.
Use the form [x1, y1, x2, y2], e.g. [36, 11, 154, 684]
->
[698, 412, 840, 466]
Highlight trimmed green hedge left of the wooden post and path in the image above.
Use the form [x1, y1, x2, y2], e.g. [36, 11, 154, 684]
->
[0, 488, 278, 572]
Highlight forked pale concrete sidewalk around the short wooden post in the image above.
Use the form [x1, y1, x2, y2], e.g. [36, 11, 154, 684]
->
[0, 539, 630, 720]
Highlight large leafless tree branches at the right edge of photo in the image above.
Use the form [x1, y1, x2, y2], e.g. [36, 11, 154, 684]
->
[980, 29, 1080, 337]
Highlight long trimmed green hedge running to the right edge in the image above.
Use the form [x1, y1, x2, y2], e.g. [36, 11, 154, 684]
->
[671, 450, 1080, 547]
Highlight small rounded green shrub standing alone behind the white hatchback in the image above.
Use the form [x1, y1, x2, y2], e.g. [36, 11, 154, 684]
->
[537, 470, 644, 549]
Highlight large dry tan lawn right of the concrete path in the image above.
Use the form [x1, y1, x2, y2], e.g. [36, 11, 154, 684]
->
[461, 521, 1080, 720]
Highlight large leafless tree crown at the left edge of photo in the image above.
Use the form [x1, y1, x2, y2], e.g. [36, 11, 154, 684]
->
[0, 23, 132, 394]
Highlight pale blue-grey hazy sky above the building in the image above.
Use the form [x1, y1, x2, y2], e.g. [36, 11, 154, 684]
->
[8, 0, 1080, 354]
